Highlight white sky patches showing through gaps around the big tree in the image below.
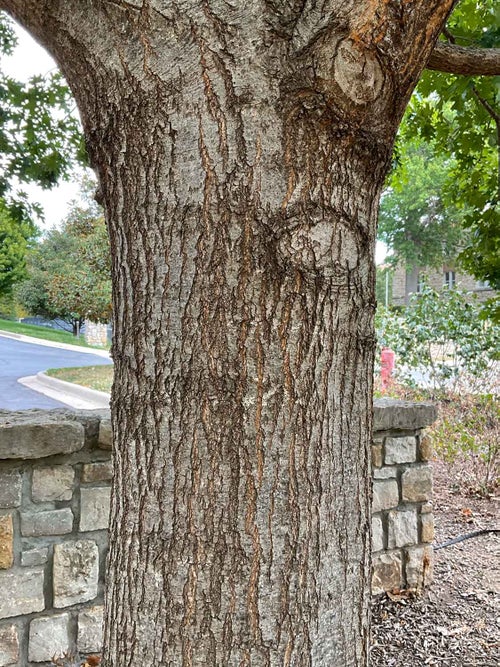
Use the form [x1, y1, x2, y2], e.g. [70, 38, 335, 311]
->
[2, 18, 387, 264]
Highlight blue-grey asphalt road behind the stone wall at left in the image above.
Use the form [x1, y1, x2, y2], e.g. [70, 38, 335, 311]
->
[0, 336, 111, 410]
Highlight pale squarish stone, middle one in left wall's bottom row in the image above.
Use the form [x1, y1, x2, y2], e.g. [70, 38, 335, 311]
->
[28, 614, 70, 662]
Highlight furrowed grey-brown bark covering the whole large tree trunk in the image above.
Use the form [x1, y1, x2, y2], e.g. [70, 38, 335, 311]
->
[2, 0, 458, 667]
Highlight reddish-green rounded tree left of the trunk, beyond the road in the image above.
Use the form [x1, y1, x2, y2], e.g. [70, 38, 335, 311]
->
[16, 187, 111, 335]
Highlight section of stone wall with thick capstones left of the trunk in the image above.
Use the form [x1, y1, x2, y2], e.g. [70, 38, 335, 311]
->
[0, 410, 111, 667]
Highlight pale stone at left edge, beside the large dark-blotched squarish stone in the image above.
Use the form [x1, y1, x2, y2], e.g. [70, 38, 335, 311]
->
[0, 568, 45, 618]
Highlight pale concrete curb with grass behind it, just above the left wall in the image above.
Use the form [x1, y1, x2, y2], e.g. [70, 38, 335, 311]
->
[18, 371, 110, 410]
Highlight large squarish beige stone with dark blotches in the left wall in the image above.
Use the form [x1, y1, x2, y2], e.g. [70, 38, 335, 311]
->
[53, 540, 99, 608]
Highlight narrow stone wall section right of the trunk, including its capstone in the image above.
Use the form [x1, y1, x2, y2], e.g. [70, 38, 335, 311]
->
[372, 399, 436, 594]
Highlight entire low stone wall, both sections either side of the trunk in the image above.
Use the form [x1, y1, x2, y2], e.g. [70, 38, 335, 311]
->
[0, 400, 435, 667]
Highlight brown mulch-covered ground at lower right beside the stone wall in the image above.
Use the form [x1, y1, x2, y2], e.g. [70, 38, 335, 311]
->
[371, 461, 500, 667]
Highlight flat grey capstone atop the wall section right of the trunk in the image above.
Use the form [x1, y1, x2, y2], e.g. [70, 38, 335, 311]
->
[373, 398, 437, 431]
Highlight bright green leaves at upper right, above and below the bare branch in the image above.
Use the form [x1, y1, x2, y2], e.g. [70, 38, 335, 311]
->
[401, 0, 500, 289]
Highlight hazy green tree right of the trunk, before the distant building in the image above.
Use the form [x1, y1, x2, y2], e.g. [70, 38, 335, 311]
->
[378, 139, 465, 268]
